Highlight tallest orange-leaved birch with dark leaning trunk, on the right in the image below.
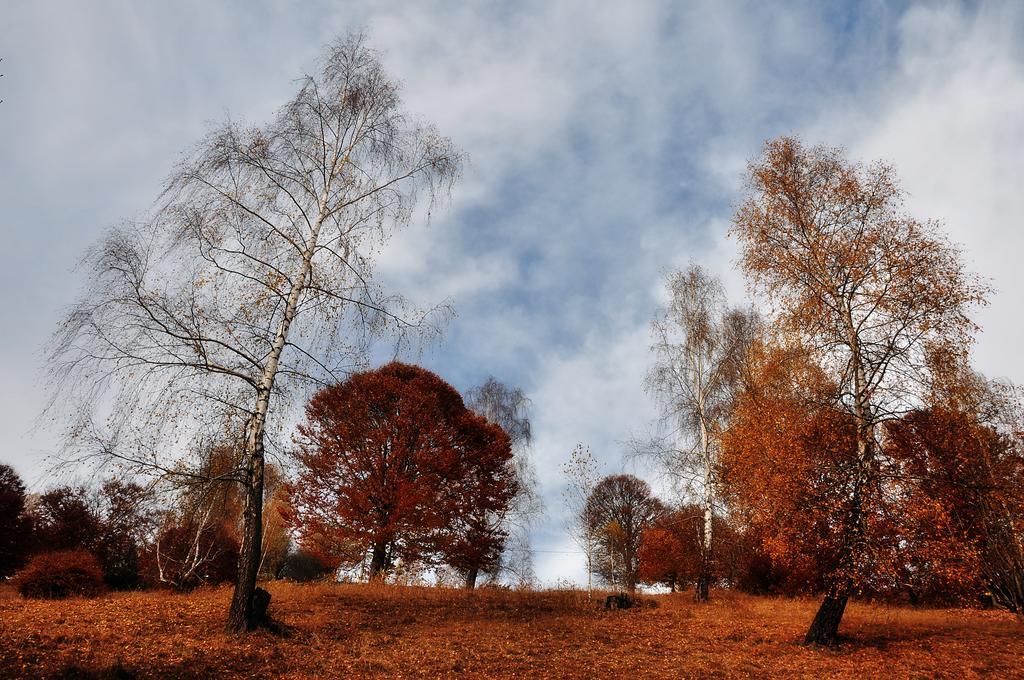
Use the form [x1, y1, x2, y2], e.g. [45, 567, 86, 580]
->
[732, 137, 987, 644]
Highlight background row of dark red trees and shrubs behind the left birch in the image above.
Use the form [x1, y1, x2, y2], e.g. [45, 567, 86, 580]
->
[0, 363, 540, 589]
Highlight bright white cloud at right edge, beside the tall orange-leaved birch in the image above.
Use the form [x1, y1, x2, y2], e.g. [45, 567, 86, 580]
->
[807, 5, 1024, 383]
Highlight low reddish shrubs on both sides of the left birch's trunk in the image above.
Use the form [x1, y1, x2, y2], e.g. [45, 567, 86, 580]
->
[0, 450, 331, 596]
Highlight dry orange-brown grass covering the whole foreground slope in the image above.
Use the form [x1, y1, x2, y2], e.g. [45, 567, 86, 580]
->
[0, 583, 1024, 679]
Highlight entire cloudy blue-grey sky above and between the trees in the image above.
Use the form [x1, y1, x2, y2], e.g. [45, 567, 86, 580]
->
[0, 0, 1024, 584]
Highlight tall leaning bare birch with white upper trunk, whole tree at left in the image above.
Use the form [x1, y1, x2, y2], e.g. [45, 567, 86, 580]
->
[48, 35, 462, 631]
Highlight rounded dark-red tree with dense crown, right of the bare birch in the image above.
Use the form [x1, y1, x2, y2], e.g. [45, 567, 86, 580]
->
[288, 363, 516, 585]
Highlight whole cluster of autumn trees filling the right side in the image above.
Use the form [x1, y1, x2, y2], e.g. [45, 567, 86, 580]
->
[566, 137, 1024, 644]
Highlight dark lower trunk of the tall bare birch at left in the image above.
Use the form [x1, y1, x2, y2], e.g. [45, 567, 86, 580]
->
[227, 441, 263, 633]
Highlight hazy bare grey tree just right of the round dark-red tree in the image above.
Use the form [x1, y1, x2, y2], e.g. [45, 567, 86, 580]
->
[466, 376, 544, 586]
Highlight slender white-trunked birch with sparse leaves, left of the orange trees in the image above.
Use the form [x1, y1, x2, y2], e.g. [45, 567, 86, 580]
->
[639, 264, 758, 601]
